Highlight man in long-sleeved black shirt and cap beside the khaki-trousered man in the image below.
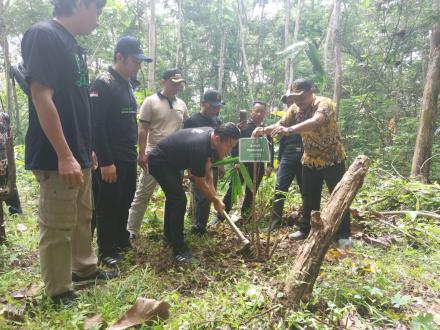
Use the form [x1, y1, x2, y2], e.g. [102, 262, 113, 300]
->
[90, 36, 151, 267]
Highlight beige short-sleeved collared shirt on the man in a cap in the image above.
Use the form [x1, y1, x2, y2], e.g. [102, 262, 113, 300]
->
[139, 93, 188, 152]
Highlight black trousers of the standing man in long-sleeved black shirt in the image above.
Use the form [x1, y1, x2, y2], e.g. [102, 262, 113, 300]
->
[96, 161, 137, 255]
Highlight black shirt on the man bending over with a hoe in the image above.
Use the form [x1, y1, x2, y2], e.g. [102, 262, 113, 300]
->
[148, 127, 215, 177]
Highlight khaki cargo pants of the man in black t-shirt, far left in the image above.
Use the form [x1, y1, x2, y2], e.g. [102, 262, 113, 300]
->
[34, 169, 97, 296]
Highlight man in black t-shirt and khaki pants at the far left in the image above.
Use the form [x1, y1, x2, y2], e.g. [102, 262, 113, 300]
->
[21, 0, 115, 303]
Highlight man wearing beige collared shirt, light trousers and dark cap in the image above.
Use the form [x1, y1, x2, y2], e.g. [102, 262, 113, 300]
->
[127, 69, 188, 238]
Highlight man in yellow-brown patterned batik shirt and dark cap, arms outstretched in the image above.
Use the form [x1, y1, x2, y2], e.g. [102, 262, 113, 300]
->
[253, 79, 351, 247]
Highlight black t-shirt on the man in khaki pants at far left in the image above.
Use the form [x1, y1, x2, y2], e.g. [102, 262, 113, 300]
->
[21, 20, 92, 170]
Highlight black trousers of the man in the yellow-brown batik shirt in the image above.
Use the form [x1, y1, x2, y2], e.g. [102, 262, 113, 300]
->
[299, 163, 350, 239]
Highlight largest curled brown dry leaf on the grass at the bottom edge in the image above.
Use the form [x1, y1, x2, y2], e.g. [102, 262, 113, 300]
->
[109, 297, 170, 330]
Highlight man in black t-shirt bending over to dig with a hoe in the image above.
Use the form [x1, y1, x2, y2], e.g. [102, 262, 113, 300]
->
[148, 123, 240, 263]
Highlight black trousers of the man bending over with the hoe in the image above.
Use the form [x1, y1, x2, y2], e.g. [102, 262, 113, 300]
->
[148, 156, 186, 254]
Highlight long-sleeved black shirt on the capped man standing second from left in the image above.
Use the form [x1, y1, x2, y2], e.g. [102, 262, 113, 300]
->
[90, 67, 137, 166]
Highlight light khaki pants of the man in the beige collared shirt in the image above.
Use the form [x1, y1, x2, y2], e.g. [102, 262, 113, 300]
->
[127, 170, 157, 235]
